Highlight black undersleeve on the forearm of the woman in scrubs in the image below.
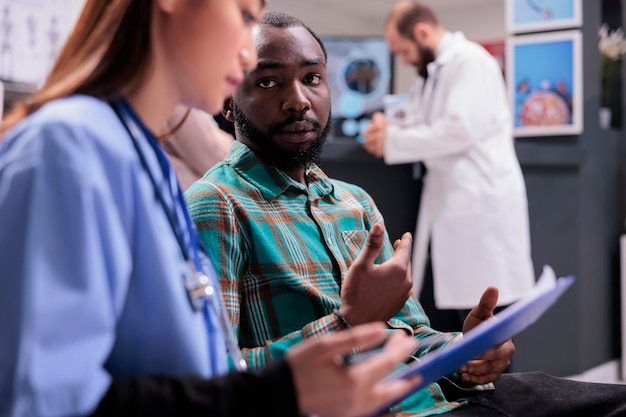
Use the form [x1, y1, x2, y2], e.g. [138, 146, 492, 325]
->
[92, 360, 299, 417]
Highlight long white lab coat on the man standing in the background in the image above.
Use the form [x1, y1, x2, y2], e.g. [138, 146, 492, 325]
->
[384, 32, 534, 309]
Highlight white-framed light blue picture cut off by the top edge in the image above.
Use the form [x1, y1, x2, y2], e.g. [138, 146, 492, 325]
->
[505, 0, 582, 33]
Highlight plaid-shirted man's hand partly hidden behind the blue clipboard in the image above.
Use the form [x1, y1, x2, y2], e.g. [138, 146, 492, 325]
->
[459, 287, 515, 385]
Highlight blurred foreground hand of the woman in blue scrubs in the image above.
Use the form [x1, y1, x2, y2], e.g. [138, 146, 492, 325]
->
[286, 323, 421, 417]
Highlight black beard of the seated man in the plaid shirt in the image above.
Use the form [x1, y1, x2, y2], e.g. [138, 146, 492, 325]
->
[232, 101, 332, 171]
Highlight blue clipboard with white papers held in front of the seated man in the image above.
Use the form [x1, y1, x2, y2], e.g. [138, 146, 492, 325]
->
[373, 267, 575, 415]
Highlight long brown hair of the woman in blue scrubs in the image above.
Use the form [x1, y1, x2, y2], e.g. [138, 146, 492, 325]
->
[0, 0, 152, 137]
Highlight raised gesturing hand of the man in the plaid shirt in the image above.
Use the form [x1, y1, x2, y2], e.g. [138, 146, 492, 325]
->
[339, 224, 413, 325]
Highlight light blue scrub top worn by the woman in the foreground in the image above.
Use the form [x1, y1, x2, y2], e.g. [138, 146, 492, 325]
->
[0, 96, 227, 417]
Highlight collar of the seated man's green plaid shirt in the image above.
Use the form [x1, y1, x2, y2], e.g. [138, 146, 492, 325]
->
[224, 141, 337, 200]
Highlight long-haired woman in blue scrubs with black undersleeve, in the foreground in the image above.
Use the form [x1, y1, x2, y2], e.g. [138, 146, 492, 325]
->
[0, 0, 415, 417]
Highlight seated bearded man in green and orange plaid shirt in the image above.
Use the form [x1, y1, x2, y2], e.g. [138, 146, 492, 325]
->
[186, 13, 626, 416]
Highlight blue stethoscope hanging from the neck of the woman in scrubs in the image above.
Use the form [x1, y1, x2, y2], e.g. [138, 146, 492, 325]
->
[110, 98, 248, 371]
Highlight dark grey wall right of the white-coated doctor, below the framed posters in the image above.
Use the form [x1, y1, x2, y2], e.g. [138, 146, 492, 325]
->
[492, 0, 624, 375]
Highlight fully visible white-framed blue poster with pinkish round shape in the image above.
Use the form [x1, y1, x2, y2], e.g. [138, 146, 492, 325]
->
[506, 30, 583, 136]
